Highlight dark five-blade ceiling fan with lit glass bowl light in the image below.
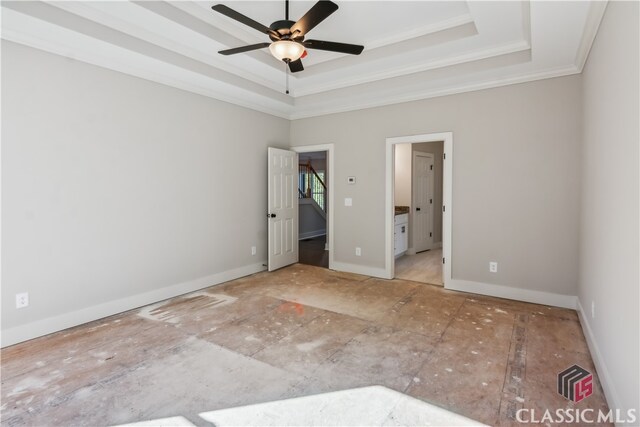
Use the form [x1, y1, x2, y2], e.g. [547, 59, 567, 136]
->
[211, 0, 364, 73]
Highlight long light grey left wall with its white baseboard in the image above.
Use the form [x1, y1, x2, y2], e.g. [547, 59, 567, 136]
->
[2, 41, 289, 344]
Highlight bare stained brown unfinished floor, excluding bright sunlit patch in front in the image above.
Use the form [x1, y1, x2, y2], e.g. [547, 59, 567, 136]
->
[1, 264, 607, 426]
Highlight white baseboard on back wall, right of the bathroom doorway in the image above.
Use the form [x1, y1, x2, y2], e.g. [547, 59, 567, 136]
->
[445, 279, 578, 310]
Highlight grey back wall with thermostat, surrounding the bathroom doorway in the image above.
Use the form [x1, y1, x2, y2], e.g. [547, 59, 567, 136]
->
[291, 76, 581, 295]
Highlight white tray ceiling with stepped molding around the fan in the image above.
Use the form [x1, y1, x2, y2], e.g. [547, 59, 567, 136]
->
[2, 0, 606, 119]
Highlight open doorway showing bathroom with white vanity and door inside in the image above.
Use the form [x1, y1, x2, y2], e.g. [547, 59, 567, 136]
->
[393, 141, 444, 286]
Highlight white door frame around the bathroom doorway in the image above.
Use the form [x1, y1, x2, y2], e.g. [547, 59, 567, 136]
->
[384, 132, 453, 288]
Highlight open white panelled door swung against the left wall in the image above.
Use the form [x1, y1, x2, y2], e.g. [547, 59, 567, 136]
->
[267, 147, 298, 271]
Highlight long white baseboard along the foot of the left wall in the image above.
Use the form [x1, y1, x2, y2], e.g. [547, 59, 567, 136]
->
[0, 262, 266, 347]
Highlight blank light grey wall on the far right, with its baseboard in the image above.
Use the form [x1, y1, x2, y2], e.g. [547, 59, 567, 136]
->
[578, 1, 640, 416]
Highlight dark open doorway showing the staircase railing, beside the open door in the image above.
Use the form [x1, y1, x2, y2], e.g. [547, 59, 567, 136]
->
[298, 151, 329, 268]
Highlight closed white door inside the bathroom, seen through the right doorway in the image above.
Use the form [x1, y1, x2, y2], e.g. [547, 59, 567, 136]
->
[412, 151, 433, 252]
